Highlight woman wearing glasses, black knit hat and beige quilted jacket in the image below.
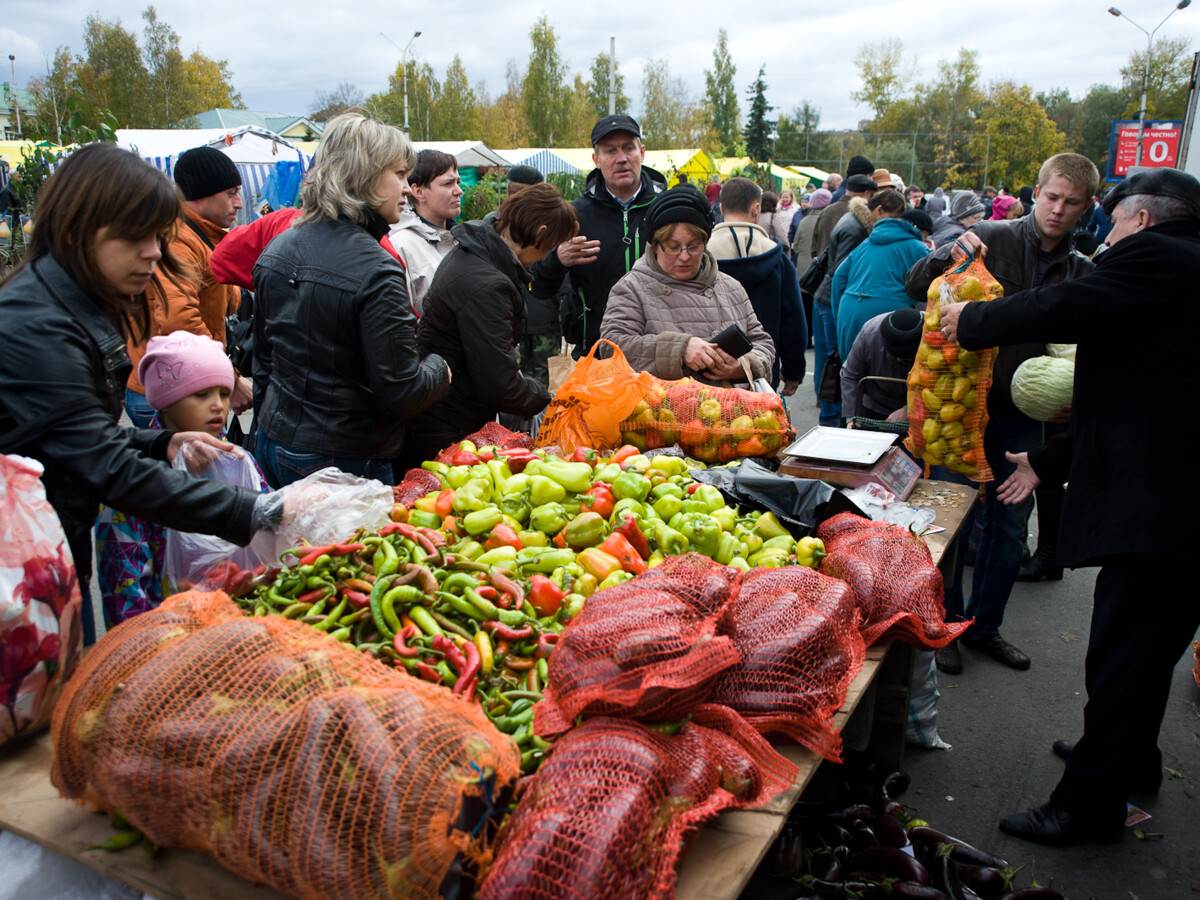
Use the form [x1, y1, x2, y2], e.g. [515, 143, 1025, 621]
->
[600, 186, 775, 384]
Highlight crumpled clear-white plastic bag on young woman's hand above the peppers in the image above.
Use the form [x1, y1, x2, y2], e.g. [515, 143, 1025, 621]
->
[250, 466, 394, 565]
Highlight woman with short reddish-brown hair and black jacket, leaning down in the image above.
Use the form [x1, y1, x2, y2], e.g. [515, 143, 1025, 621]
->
[404, 184, 578, 467]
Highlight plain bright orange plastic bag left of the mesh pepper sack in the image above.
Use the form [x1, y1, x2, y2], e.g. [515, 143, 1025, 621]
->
[538, 341, 654, 455]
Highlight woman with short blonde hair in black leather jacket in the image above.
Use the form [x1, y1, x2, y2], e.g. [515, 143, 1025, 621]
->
[254, 113, 450, 487]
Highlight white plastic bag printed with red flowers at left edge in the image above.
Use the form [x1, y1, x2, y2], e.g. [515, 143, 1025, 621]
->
[0, 455, 83, 744]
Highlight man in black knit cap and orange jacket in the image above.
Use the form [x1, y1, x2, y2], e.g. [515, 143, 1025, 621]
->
[125, 146, 252, 427]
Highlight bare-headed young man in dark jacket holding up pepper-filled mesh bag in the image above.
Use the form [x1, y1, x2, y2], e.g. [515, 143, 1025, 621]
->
[905, 154, 1100, 674]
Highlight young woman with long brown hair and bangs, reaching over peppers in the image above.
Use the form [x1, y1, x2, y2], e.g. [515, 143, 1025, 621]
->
[0, 144, 282, 642]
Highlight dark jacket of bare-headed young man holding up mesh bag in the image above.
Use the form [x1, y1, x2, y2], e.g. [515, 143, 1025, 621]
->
[905, 216, 1094, 427]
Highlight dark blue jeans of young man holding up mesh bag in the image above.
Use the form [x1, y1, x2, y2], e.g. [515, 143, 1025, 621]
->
[947, 419, 1042, 640]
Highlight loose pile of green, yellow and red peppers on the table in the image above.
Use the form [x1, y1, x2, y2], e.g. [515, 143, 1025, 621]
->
[226, 442, 824, 770]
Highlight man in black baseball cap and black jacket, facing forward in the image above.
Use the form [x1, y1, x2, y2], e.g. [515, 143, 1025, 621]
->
[530, 115, 667, 358]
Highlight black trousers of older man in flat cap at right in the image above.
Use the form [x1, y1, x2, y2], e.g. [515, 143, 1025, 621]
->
[1050, 556, 1200, 828]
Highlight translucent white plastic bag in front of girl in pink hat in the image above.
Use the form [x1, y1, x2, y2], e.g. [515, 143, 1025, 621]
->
[163, 442, 263, 590]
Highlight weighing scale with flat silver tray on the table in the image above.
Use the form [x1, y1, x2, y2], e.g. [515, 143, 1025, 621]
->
[779, 425, 923, 500]
